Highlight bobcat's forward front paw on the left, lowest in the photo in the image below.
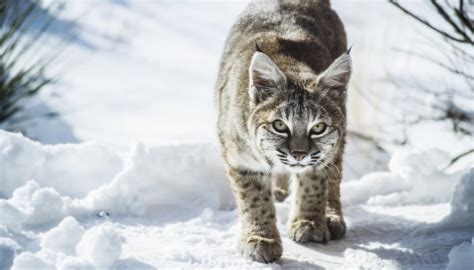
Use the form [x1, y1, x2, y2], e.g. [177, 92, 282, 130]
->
[241, 235, 283, 263]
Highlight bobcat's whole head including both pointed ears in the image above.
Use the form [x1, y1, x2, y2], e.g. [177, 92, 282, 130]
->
[247, 52, 351, 173]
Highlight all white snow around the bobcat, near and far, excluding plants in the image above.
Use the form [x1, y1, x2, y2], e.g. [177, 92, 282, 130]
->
[0, 0, 474, 269]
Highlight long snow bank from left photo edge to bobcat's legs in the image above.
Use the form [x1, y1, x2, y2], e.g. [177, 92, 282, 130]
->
[0, 131, 234, 230]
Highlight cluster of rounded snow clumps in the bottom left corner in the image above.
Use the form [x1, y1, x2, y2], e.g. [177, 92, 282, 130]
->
[11, 217, 122, 269]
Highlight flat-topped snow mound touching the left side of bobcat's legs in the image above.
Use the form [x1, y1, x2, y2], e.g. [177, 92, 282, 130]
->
[84, 144, 233, 216]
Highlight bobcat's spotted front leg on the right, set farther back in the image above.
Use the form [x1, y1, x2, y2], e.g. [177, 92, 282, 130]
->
[288, 169, 330, 243]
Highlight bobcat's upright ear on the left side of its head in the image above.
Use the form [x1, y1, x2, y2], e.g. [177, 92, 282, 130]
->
[249, 52, 286, 103]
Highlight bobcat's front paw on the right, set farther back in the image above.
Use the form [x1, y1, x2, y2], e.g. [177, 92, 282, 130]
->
[288, 220, 331, 243]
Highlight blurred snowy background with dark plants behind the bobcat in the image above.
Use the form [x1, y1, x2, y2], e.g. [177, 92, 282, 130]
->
[0, 0, 474, 179]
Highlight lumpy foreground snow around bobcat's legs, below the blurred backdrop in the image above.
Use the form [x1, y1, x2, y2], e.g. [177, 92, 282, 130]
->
[0, 131, 474, 269]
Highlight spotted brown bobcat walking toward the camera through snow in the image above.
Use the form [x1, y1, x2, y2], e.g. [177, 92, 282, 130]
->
[216, 0, 351, 263]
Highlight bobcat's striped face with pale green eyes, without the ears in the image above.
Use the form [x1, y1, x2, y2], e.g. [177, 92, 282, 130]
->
[255, 83, 345, 173]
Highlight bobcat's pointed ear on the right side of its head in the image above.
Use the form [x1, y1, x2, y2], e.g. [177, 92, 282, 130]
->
[316, 49, 352, 90]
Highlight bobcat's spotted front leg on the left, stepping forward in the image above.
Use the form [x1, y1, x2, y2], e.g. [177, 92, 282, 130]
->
[229, 169, 283, 263]
